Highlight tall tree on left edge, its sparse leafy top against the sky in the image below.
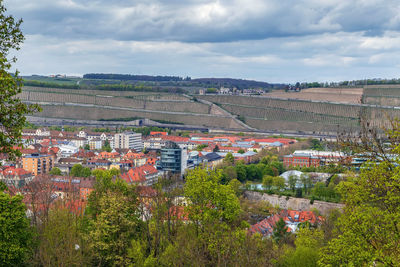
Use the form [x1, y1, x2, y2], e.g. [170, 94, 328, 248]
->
[0, 1, 40, 159]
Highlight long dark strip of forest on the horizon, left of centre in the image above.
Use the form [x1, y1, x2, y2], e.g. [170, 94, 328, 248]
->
[83, 73, 186, 82]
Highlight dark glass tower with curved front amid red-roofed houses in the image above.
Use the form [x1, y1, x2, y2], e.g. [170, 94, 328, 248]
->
[161, 142, 183, 173]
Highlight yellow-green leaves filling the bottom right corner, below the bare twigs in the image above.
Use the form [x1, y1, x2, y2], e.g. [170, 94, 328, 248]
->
[320, 160, 400, 266]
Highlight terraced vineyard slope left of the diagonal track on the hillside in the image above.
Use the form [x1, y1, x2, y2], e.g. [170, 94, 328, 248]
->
[18, 87, 245, 130]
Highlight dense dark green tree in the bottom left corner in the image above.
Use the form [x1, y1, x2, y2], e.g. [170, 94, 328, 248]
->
[0, 182, 32, 266]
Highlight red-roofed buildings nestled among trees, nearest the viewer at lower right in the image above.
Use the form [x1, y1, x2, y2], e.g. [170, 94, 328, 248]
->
[249, 210, 323, 237]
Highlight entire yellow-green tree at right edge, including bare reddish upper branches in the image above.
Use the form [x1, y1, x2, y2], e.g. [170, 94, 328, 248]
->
[319, 120, 400, 266]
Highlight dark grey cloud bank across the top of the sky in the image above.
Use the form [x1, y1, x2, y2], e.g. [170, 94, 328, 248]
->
[7, 0, 400, 42]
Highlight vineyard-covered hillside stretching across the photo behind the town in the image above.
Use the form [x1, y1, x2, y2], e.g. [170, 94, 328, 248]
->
[19, 86, 400, 135]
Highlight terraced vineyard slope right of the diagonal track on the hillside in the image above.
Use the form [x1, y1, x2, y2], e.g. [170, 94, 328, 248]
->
[199, 92, 400, 134]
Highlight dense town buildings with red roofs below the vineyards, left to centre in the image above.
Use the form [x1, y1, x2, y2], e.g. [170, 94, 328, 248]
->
[0, 128, 296, 191]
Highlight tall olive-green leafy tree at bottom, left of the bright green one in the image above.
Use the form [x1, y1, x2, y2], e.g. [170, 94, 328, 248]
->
[84, 170, 140, 266]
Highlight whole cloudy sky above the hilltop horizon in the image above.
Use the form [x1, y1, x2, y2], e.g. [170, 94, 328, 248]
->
[3, 0, 400, 83]
